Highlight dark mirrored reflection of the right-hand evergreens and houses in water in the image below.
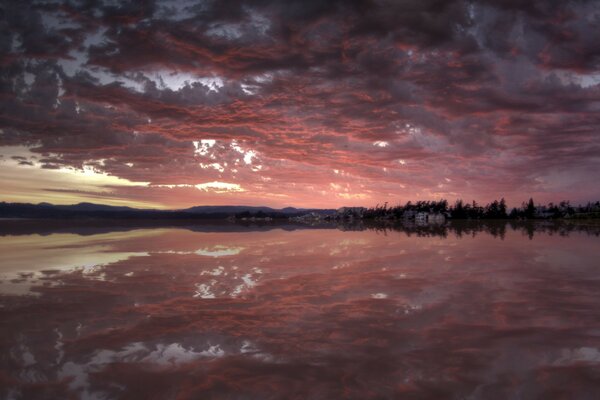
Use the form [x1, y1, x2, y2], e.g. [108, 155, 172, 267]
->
[337, 220, 600, 239]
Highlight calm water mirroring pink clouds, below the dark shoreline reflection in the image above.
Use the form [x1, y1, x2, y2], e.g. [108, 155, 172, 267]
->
[0, 225, 600, 400]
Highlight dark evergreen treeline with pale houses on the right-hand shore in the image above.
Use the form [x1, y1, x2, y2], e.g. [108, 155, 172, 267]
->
[363, 198, 600, 219]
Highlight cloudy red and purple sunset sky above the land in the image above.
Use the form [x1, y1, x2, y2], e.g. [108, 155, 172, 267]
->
[0, 0, 600, 208]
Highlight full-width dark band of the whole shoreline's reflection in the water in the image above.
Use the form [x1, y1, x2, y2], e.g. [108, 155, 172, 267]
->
[0, 219, 600, 239]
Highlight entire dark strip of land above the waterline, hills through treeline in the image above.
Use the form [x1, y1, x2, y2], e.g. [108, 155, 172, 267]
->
[0, 199, 600, 223]
